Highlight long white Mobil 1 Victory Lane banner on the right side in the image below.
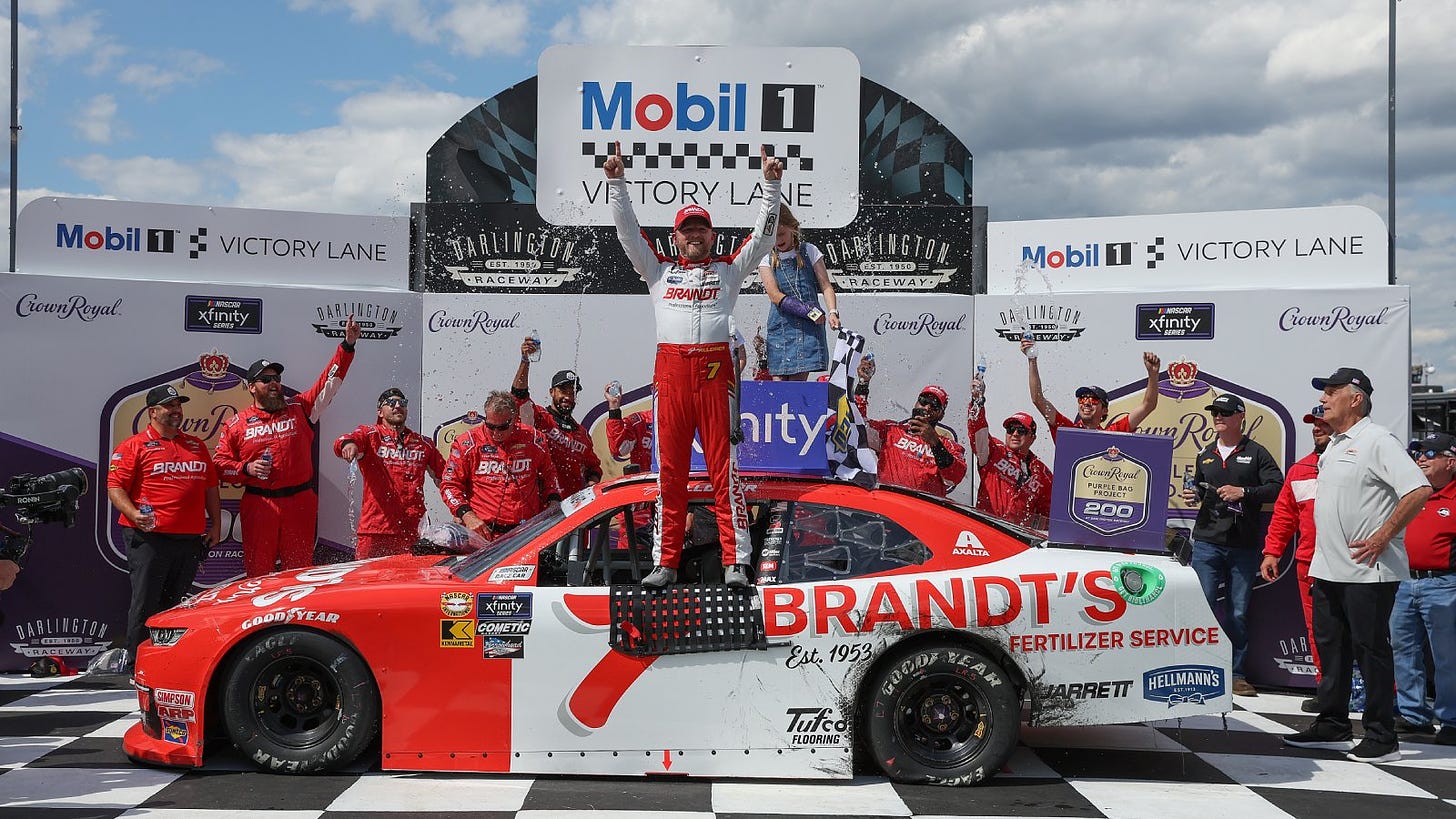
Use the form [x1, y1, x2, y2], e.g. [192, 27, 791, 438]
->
[986, 205, 1386, 296]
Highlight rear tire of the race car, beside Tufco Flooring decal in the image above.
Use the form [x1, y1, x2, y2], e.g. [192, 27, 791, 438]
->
[862, 641, 1021, 785]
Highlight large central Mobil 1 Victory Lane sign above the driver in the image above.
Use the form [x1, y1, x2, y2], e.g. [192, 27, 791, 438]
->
[536, 45, 859, 227]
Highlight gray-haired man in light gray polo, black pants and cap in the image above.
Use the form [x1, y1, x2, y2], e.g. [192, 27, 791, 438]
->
[1284, 367, 1431, 762]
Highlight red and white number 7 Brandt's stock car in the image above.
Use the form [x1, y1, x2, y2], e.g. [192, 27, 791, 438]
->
[124, 475, 1232, 784]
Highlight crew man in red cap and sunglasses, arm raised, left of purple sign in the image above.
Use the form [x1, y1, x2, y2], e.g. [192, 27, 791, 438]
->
[965, 370, 1051, 529]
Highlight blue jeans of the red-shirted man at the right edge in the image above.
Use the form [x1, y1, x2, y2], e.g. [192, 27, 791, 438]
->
[1390, 574, 1456, 726]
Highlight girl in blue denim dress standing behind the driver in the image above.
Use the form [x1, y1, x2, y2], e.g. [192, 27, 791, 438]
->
[759, 204, 839, 380]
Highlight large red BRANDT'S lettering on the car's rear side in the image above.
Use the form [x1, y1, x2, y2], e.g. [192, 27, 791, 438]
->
[763, 570, 1127, 638]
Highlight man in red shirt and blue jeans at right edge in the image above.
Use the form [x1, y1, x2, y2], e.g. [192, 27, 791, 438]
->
[1390, 433, 1456, 745]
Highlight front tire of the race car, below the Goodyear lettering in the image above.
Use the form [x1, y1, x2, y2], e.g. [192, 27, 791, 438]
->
[223, 628, 380, 774]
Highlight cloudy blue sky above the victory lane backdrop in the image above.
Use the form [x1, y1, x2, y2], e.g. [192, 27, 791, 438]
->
[4, 0, 1456, 385]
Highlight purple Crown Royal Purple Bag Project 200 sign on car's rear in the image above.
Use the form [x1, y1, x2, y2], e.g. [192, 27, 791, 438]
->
[1048, 427, 1174, 552]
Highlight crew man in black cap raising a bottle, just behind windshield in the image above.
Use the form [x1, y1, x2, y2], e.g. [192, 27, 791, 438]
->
[511, 337, 601, 495]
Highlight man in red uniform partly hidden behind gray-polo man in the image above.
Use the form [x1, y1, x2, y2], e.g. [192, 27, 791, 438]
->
[1259, 404, 1333, 687]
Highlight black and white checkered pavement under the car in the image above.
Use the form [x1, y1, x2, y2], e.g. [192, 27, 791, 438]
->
[0, 675, 1456, 819]
